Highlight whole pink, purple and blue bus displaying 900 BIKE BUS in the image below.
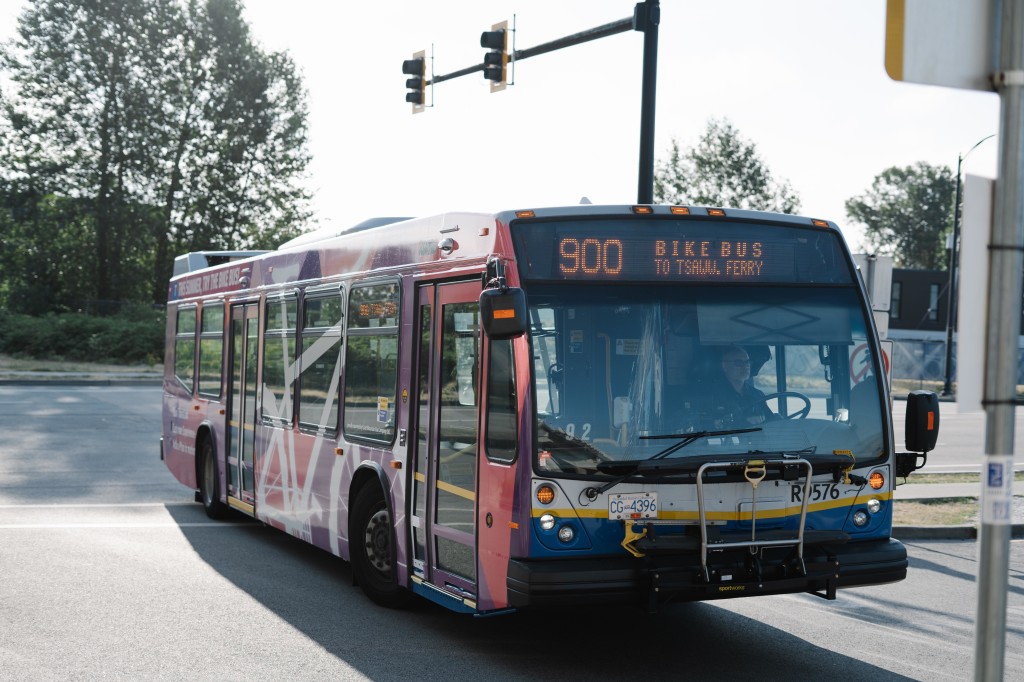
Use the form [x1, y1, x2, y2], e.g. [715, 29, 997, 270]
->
[161, 206, 938, 613]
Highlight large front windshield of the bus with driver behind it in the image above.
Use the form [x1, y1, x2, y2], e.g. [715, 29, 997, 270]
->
[527, 283, 885, 475]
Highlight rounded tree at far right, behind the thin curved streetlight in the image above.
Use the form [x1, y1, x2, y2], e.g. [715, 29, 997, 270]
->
[846, 162, 956, 270]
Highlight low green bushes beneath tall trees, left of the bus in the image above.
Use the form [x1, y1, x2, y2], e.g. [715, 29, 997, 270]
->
[0, 306, 164, 365]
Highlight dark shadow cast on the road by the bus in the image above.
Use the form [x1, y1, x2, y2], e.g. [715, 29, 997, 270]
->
[167, 505, 906, 682]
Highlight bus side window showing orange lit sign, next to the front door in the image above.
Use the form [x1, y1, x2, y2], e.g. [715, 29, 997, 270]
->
[344, 283, 398, 441]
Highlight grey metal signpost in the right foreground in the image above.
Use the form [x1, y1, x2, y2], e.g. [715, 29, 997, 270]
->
[974, 0, 1024, 682]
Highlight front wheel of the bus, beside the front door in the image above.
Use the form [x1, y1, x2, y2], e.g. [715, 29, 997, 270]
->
[350, 483, 411, 608]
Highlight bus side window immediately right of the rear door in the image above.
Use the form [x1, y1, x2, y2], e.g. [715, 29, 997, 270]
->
[263, 294, 298, 426]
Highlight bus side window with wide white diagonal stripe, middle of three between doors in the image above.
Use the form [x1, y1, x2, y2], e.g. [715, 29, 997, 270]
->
[299, 287, 344, 432]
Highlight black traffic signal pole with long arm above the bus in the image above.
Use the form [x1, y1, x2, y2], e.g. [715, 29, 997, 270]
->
[403, 0, 662, 204]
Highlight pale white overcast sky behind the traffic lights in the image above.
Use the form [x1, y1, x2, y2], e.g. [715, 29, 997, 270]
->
[0, 0, 999, 250]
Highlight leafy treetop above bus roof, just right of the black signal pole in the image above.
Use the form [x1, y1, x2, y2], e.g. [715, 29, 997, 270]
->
[654, 119, 800, 213]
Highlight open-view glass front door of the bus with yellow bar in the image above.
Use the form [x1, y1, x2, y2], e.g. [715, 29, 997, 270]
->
[412, 280, 480, 598]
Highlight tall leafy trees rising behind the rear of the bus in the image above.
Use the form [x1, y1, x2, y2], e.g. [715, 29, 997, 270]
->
[0, 0, 309, 302]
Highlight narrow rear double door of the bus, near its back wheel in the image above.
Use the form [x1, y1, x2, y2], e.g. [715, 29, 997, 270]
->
[225, 301, 259, 514]
